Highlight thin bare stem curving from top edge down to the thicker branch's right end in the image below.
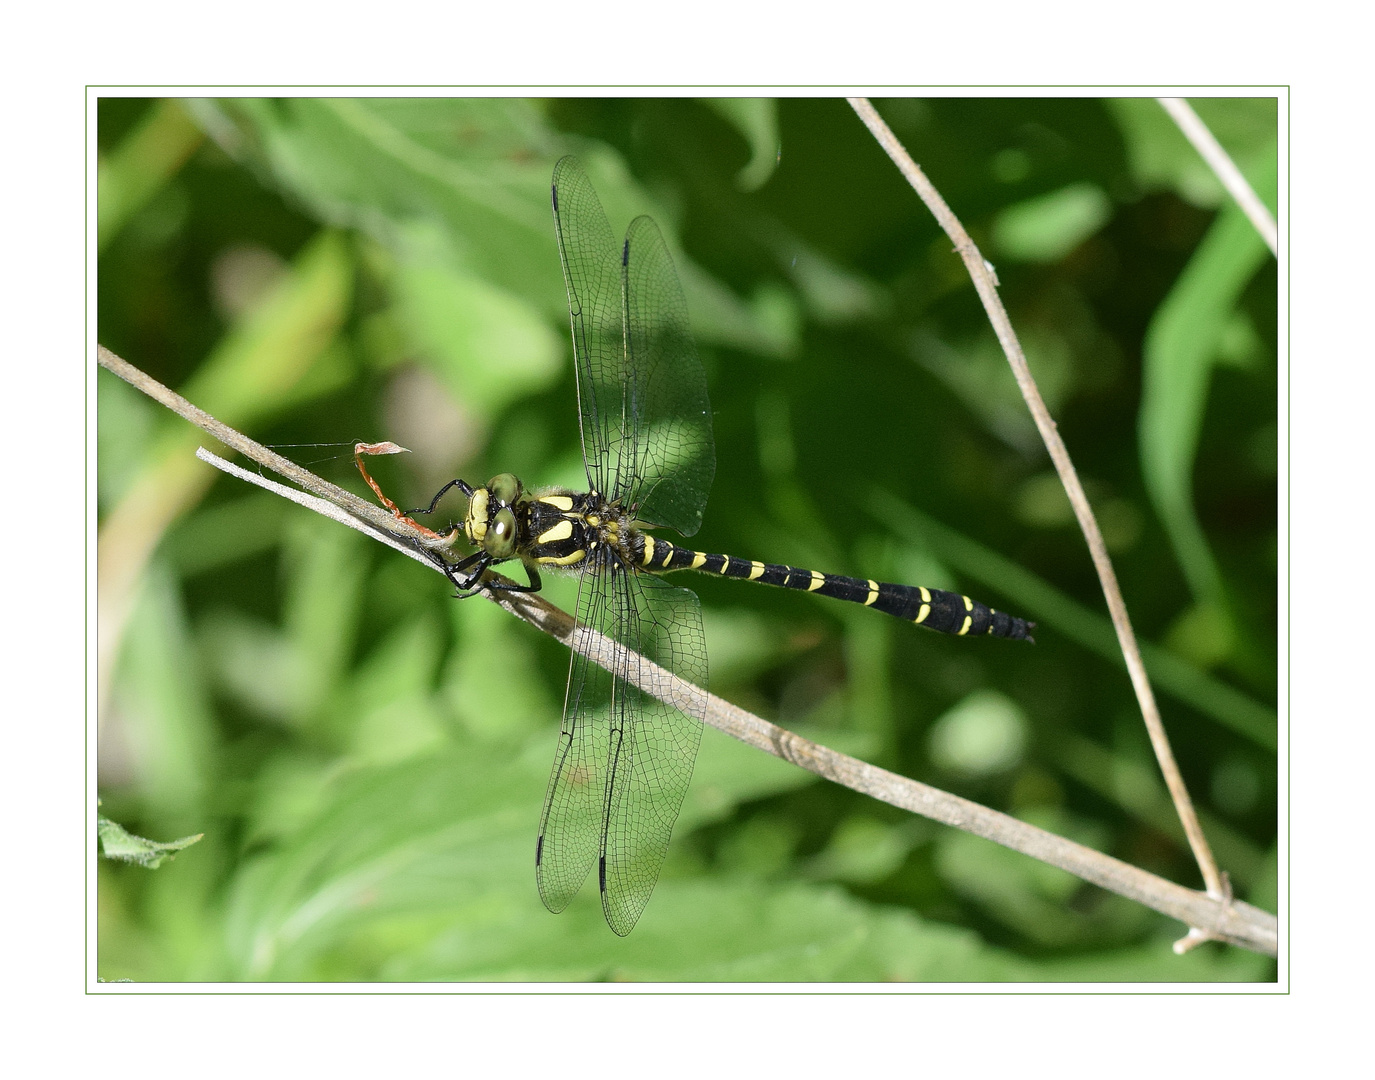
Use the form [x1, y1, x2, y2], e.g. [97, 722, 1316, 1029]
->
[850, 98, 1228, 929]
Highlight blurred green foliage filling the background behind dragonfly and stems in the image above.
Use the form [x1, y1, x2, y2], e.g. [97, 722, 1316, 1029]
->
[98, 98, 1279, 981]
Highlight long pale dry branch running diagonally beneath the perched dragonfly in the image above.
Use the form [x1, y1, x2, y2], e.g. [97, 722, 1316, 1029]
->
[100, 349, 1279, 956]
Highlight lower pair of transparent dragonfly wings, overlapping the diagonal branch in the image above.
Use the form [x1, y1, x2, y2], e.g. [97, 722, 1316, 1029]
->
[536, 555, 707, 937]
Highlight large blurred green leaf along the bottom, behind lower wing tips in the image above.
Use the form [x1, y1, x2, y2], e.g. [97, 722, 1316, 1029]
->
[226, 737, 1029, 981]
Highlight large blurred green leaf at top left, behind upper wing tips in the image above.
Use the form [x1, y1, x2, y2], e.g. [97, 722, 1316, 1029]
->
[195, 98, 795, 363]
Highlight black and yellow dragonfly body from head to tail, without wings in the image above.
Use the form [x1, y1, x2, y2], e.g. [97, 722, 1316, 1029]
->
[445, 488, 1034, 641]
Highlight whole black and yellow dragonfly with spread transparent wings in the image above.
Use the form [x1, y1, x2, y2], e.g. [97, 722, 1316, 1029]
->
[356, 157, 1035, 937]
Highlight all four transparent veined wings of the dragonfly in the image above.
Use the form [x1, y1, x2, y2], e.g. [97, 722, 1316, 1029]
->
[535, 157, 715, 936]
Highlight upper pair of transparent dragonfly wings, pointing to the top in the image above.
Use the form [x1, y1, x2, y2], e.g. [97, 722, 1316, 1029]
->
[553, 157, 715, 537]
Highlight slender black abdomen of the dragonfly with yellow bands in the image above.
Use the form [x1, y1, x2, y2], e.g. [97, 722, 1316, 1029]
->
[634, 534, 1035, 641]
